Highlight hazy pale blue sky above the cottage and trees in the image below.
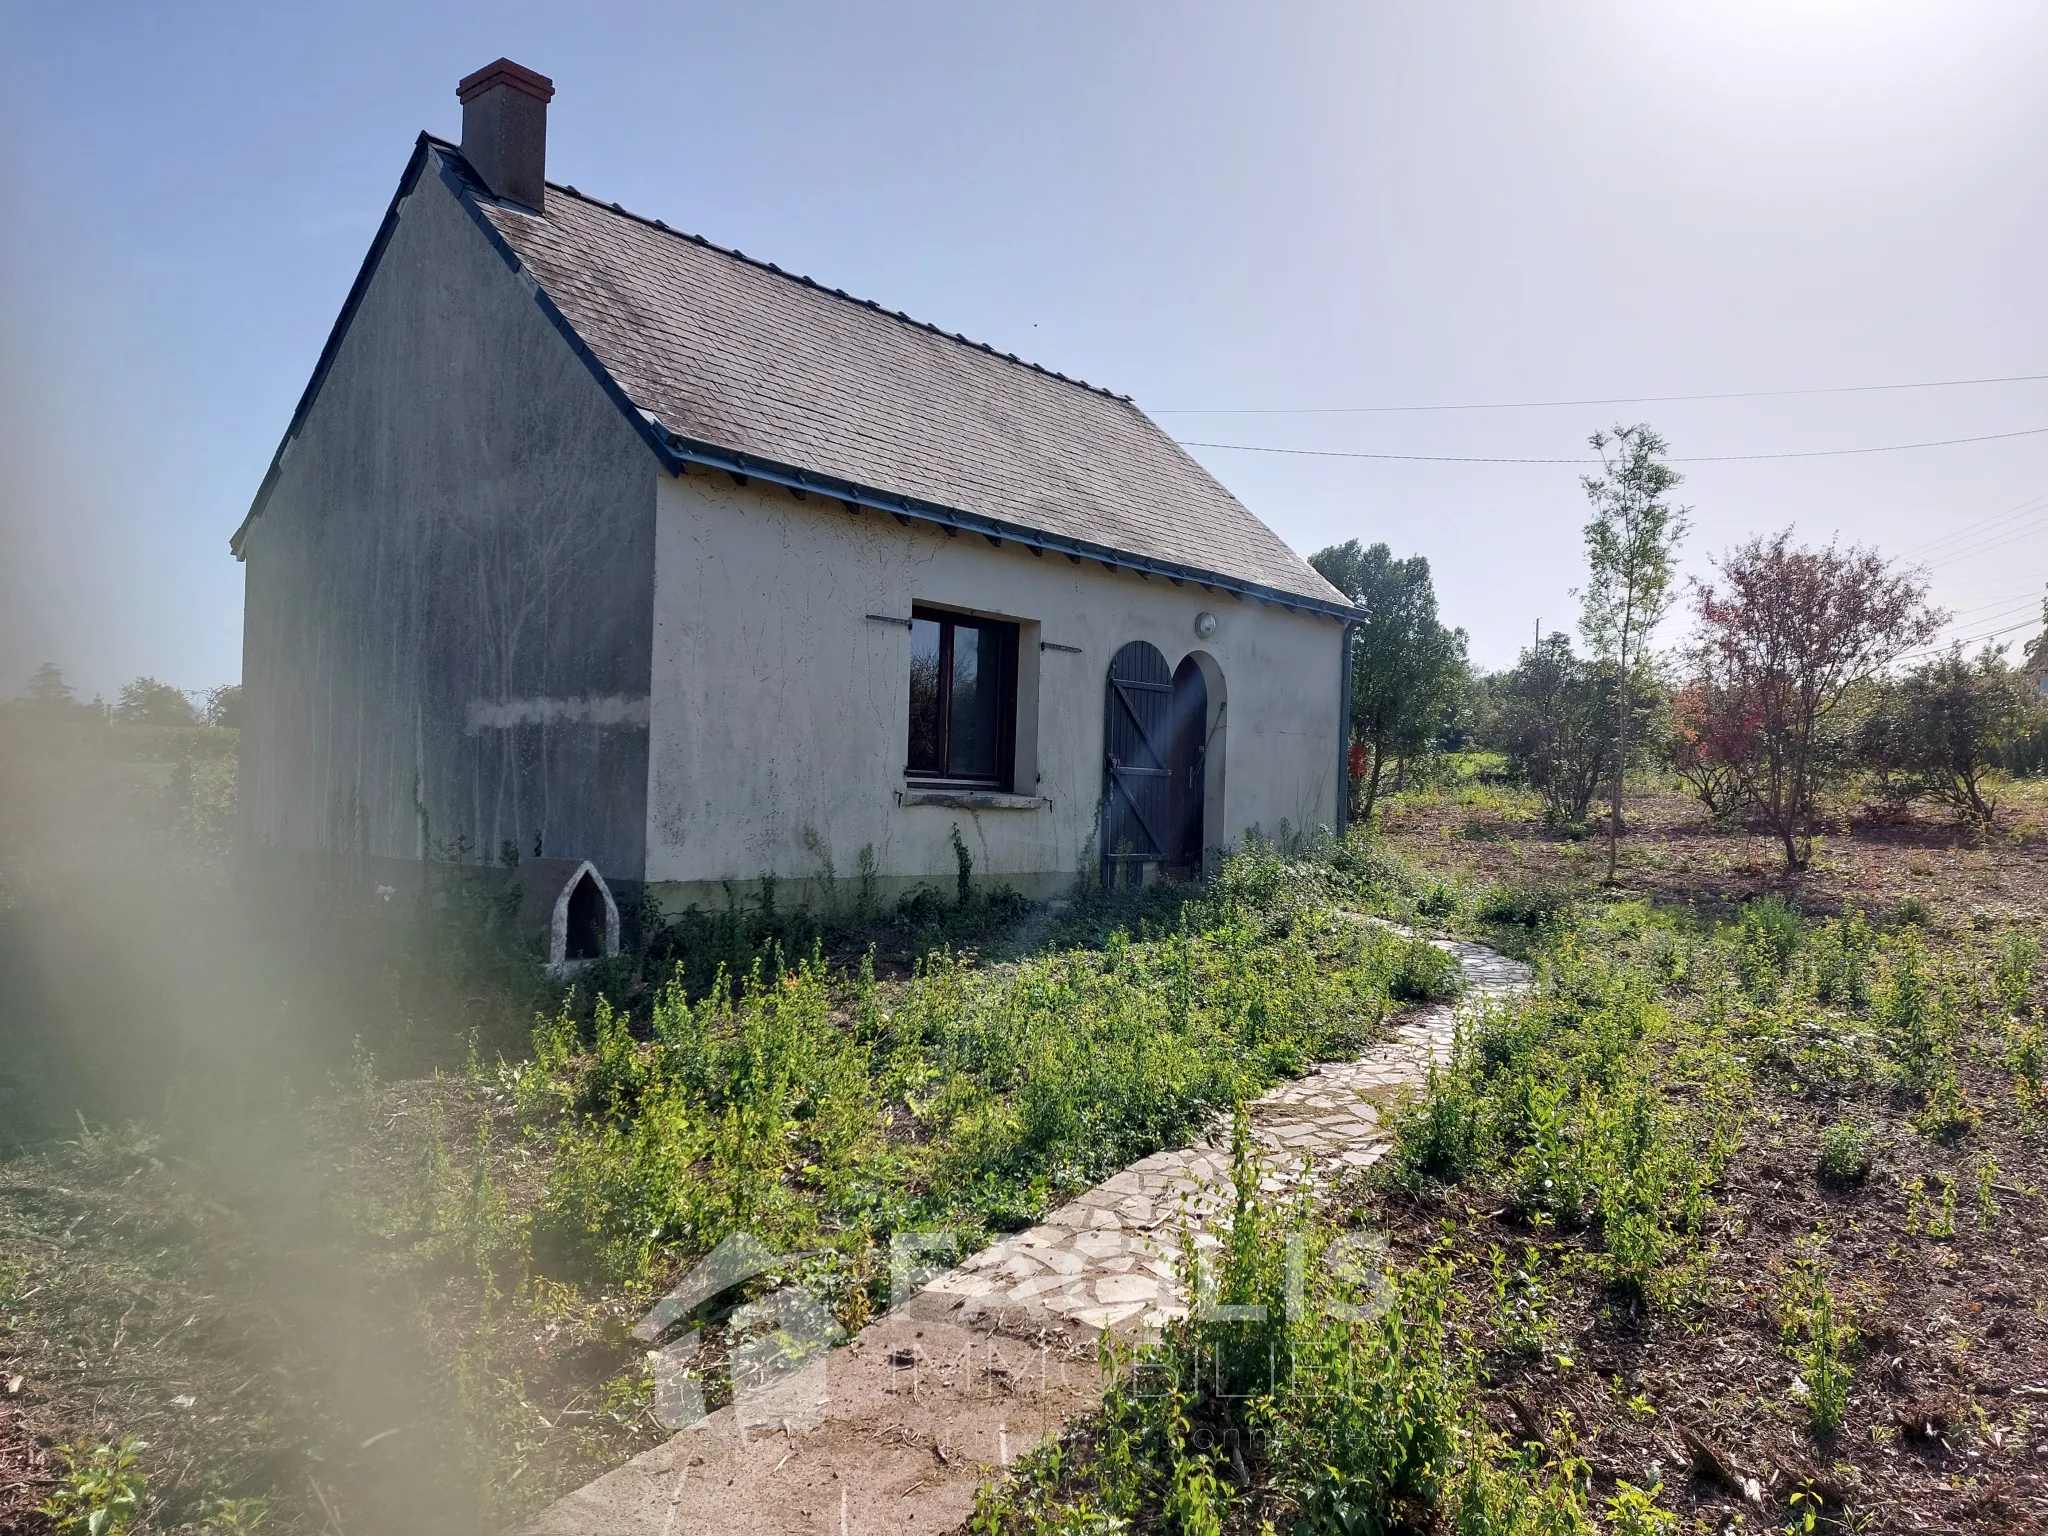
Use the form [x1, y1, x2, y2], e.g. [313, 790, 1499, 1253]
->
[0, 0, 2048, 692]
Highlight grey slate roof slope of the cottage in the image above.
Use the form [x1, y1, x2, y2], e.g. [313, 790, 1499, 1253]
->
[436, 145, 1343, 604]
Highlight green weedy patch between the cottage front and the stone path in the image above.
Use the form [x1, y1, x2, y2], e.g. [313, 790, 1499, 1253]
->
[514, 854, 1456, 1284]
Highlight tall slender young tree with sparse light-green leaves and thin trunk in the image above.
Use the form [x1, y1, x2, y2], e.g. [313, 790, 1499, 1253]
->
[1577, 424, 1686, 883]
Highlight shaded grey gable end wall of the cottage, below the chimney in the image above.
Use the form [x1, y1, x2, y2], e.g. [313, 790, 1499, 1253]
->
[240, 162, 657, 881]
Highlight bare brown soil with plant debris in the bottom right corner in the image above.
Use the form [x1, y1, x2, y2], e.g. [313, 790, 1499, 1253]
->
[1370, 1069, 2048, 1532]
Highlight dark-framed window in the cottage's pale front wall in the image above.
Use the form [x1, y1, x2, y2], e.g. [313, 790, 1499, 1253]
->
[905, 608, 1018, 788]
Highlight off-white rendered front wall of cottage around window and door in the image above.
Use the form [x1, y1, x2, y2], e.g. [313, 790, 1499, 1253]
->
[647, 469, 1341, 901]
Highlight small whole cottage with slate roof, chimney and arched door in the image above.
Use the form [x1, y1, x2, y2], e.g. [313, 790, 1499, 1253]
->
[233, 59, 1356, 961]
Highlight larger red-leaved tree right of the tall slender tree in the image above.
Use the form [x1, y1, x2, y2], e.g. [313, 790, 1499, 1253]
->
[1694, 528, 1948, 870]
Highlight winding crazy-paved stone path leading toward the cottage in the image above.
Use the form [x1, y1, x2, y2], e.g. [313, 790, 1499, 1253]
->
[524, 920, 1530, 1536]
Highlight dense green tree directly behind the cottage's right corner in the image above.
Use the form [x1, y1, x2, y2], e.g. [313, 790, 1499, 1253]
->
[1309, 539, 1466, 821]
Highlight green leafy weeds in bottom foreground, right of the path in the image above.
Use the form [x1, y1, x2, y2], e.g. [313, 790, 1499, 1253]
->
[971, 1118, 1669, 1536]
